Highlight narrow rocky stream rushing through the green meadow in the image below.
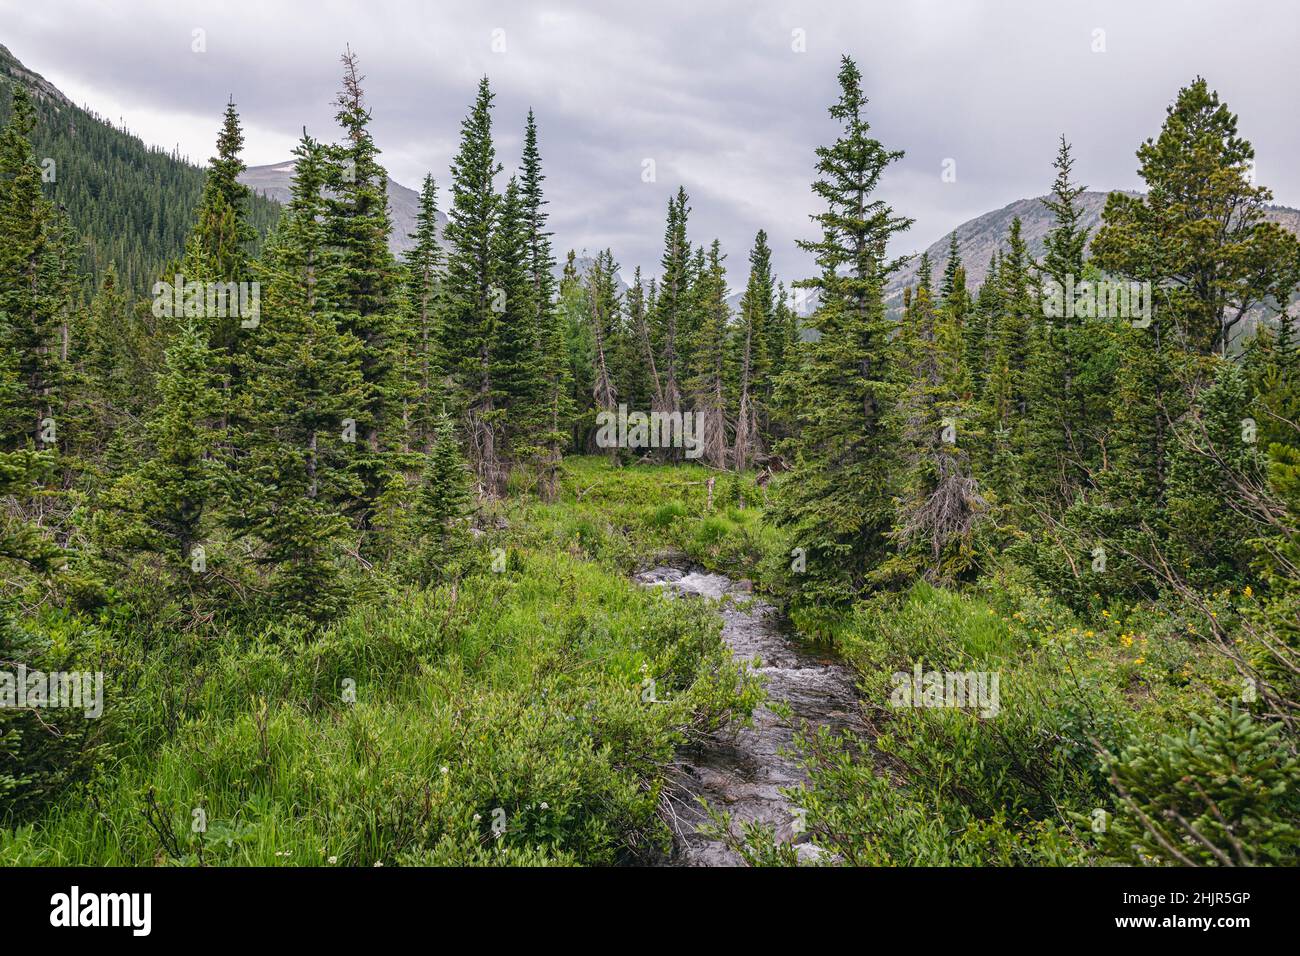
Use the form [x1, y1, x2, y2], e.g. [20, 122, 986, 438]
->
[636, 567, 859, 866]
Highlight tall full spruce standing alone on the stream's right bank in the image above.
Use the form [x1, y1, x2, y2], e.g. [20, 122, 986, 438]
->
[775, 57, 911, 600]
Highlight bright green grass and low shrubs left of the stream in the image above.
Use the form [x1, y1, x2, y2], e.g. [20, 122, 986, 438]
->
[0, 460, 759, 866]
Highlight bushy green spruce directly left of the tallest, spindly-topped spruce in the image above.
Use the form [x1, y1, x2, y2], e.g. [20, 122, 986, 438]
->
[233, 137, 364, 622]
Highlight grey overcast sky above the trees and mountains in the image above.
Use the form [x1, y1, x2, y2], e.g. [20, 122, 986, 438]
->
[0, 0, 1300, 286]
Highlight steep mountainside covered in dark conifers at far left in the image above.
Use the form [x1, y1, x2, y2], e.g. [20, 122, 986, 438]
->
[0, 46, 280, 294]
